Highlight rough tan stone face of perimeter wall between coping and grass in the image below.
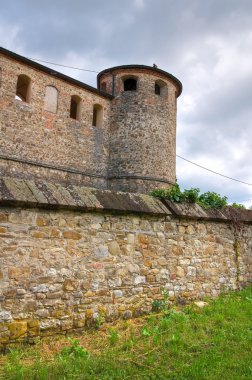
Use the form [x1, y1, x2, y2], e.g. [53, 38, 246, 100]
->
[0, 182, 252, 345]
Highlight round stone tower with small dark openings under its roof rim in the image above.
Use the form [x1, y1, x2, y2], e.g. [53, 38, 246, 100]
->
[97, 65, 182, 193]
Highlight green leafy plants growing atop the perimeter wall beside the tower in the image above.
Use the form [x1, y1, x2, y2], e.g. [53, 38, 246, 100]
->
[150, 183, 245, 209]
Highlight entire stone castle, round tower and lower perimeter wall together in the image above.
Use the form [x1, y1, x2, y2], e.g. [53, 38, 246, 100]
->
[0, 49, 252, 344]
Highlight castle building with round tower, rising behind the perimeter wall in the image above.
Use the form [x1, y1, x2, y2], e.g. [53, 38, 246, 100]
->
[0, 48, 182, 193]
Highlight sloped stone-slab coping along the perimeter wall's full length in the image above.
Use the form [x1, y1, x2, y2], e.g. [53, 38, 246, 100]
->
[0, 177, 252, 223]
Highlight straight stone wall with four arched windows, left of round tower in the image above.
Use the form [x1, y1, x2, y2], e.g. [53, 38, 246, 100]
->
[0, 55, 110, 188]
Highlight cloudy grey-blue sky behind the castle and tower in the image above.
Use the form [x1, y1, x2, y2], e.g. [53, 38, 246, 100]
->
[0, 0, 252, 206]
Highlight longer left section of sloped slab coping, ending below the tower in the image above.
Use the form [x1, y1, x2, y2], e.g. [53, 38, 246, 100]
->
[0, 177, 171, 216]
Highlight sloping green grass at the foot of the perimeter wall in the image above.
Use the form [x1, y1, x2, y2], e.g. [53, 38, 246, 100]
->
[0, 287, 252, 380]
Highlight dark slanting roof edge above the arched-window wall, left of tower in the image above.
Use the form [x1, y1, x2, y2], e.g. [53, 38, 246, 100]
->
[0, 47, 113, 99]
